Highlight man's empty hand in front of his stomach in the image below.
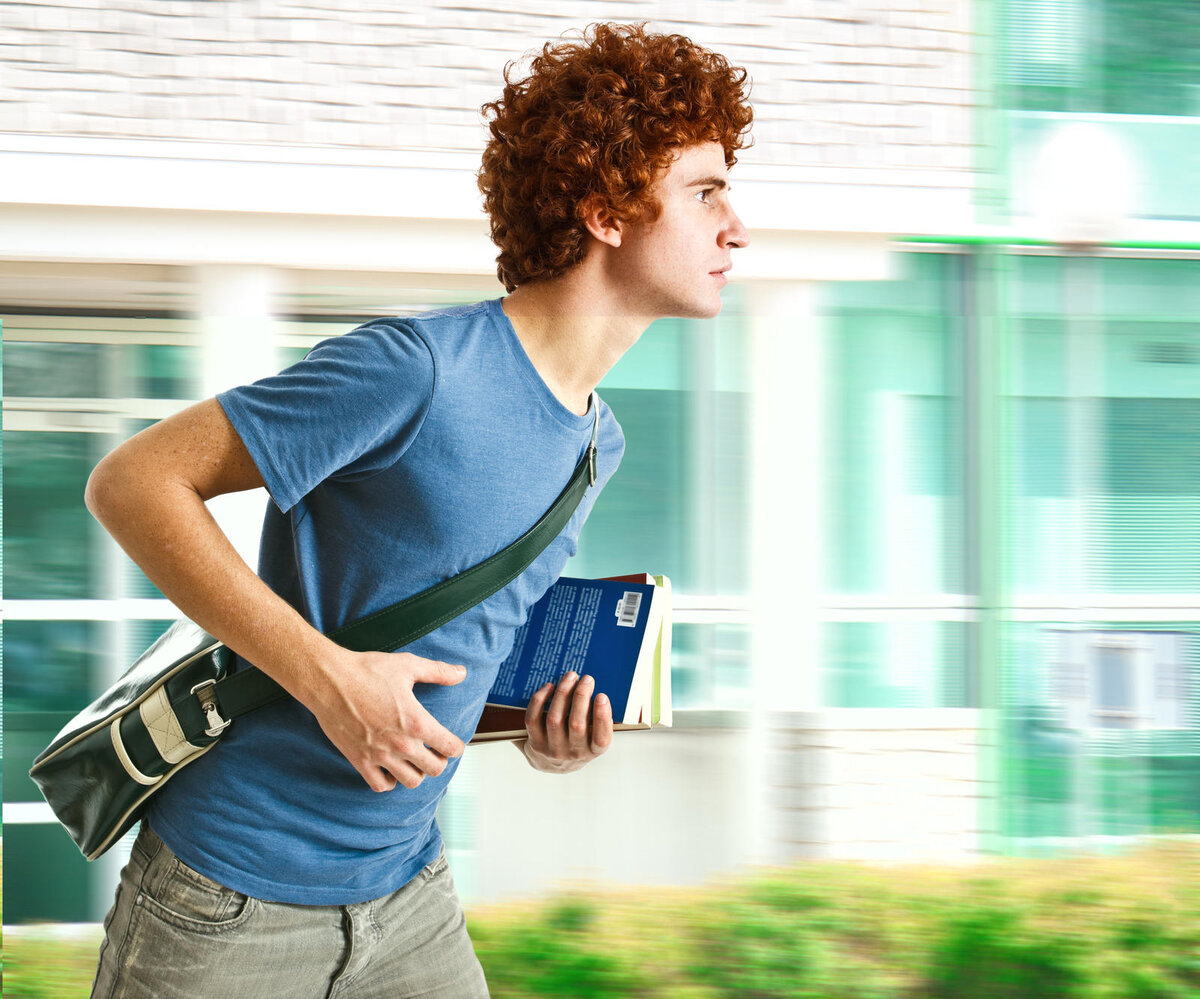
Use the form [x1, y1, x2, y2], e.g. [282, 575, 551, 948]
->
[308, 652, 467, 791]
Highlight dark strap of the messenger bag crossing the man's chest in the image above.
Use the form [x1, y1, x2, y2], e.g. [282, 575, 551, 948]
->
[187, 393, 600, 735]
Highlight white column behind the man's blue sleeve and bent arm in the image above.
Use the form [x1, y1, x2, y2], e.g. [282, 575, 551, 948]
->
[194, 264, 277, 566]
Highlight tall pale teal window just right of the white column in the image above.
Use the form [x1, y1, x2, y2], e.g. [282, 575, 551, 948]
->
[821, 252, 977, 707]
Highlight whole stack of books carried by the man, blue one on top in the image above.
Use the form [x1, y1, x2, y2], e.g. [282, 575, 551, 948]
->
[470, 573, 672, 742]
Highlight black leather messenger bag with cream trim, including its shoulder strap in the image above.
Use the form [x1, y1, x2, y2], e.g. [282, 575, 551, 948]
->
[29, 405, 599, 860]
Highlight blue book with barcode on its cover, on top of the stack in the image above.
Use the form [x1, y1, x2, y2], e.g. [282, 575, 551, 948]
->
[487, 576, 662, 724]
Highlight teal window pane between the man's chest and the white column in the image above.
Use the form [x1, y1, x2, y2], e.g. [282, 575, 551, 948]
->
[566, 315, 751, 594]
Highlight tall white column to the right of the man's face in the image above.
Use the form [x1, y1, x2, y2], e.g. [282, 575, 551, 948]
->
[748, 281, 828, 862]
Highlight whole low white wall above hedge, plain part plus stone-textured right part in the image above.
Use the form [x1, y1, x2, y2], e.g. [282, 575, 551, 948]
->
[443, 708, 989, 904]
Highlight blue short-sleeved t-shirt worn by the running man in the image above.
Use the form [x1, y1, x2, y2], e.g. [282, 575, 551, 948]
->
[150, 299, 624, 905]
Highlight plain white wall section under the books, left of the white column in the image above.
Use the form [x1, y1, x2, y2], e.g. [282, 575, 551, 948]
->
[446, 712, 754, 902]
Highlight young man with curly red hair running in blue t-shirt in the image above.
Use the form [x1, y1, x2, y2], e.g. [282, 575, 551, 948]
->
[86, 17, 751, 999]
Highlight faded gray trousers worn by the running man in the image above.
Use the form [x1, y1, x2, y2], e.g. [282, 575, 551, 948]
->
[91, 822, 487, 999]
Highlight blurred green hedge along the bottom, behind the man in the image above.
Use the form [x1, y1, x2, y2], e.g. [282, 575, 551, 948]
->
[4, 842, 1200, 999]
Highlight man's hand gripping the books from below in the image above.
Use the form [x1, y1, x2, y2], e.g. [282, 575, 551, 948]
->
[521, 672, 612, 773]
